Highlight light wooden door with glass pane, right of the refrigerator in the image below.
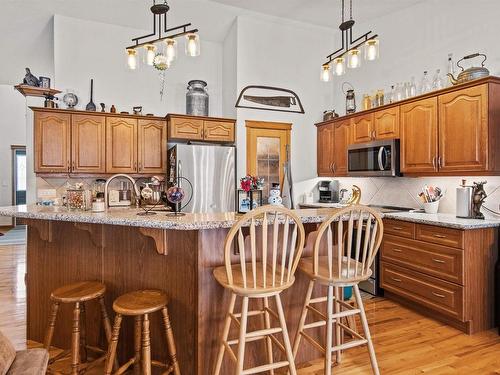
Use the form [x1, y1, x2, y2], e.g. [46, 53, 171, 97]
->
[246, 121, 292, 202]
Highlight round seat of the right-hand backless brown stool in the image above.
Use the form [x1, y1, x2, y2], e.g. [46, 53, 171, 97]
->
[113, 290, 168, 315]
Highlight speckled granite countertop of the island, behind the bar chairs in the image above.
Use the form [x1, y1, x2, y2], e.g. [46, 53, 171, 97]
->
[0, 205, 344, 230]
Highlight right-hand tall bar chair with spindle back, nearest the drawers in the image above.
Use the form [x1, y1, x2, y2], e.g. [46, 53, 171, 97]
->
[293, 206, 384, 375]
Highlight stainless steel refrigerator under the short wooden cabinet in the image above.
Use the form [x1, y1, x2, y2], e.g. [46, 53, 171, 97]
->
[167, 144, 236, 212]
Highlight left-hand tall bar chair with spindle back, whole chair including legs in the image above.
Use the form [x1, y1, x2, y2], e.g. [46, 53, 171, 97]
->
[214, 206, 305, 375]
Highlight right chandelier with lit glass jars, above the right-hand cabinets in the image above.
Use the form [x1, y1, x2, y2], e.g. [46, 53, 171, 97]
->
[321, 0, 379, 82]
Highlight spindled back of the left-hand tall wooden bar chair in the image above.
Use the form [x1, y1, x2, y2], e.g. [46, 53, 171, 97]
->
[224, 205, 305, 292]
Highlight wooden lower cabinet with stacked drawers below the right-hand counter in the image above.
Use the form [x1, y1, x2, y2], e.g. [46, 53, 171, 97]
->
[380, 219, 498, 334]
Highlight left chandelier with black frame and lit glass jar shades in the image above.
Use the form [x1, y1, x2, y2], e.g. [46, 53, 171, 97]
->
[126, 0, 200, 72]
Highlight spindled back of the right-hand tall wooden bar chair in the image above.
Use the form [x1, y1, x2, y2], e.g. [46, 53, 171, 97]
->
[313, 205, 383, 284]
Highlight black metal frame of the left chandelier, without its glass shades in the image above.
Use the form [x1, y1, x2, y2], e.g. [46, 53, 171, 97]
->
[126, 0, 198, 50]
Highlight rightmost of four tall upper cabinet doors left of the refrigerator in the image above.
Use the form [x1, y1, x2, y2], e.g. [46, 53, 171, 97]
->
[137, 120, 167, 173]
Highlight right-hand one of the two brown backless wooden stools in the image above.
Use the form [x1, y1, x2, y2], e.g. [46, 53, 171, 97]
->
[105, 290, 181, 375]
